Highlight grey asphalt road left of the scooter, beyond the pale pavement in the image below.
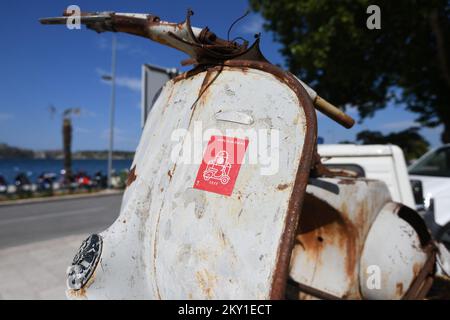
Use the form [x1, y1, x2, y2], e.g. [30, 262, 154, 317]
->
[0, 194, 122, 248]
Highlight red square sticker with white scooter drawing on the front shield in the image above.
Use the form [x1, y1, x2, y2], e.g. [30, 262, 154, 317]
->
[194, 136, 248, 196]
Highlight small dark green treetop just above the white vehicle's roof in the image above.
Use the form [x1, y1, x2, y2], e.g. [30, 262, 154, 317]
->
[356, 127, 430, 160]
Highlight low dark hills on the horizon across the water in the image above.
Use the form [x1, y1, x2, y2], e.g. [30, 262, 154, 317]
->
[0, 143, 134, 160]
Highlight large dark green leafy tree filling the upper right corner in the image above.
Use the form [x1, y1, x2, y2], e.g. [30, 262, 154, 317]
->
[250, 0, 450, 142]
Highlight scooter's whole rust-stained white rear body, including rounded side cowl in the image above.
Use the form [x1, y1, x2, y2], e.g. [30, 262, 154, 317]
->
[290, 179, 436, 299]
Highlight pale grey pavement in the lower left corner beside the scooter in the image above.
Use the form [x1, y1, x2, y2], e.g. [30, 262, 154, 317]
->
[0, 234, 88, 300]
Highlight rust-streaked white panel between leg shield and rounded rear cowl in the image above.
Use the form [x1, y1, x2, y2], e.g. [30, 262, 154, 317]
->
[290, 178, 390, 299]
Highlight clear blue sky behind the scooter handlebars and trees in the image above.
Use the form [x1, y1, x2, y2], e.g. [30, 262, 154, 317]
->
[0, 0, 440, 150]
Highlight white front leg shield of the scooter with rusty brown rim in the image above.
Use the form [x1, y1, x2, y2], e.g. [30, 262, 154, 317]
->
[68, 61, 316, 299]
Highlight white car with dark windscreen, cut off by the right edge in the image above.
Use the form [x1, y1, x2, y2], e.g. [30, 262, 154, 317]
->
[409, 144, 450, 248]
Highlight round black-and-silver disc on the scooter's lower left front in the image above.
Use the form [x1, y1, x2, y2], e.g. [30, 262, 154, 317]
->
[67, 234, 103, 290]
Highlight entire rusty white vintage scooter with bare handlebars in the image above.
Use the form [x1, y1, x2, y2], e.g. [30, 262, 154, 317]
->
[41, 12, 448, 299]
